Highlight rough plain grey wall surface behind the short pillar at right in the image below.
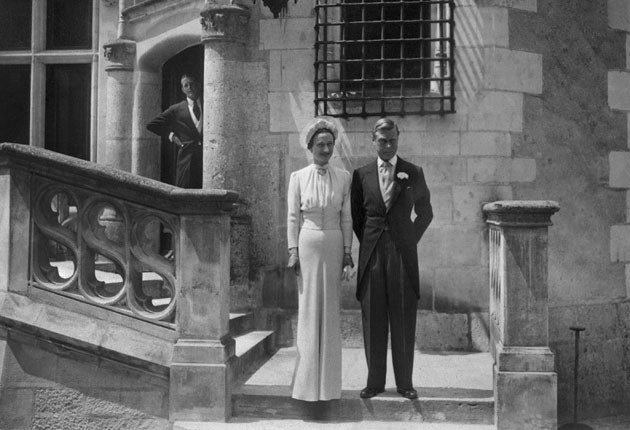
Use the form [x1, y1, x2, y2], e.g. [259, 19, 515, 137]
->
[509, 0, 630, 422]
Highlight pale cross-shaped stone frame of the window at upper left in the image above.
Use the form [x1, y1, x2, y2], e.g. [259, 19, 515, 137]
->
[0, 0, 100, 161]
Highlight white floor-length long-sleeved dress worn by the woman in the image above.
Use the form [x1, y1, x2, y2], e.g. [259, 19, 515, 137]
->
[287, 164, 352, 401]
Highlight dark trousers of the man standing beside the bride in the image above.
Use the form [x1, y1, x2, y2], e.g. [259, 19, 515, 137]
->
[361, 230, 418, 390]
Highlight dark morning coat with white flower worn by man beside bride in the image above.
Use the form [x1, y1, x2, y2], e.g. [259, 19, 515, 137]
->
[351, 157, 433, 300]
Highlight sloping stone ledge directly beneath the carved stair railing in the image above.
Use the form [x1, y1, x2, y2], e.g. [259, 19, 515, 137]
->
[0, 292, 173, 376]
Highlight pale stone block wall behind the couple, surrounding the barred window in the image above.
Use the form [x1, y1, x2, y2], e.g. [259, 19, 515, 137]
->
[251, 0, 543, 313]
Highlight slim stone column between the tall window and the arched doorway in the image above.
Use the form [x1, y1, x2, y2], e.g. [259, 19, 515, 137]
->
[97, 39, 136, 172]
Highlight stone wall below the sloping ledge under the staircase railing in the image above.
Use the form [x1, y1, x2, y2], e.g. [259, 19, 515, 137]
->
[0, 329, 170, 430]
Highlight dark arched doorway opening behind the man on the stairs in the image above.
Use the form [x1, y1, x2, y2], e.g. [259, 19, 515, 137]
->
[160, 45, 204, 184]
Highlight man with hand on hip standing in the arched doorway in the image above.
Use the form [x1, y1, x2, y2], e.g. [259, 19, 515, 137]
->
[147, 75, 203, 188]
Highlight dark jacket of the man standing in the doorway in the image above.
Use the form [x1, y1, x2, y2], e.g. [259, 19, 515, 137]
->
[147, 100, 203, 145]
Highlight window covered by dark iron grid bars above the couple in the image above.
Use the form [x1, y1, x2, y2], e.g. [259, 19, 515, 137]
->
[315, 0, 455, 117]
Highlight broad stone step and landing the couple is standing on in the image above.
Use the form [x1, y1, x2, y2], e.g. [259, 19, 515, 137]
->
[232, 348, 494, 425]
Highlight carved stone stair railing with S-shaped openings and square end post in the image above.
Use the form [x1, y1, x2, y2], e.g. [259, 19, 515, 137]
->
[0, 143, 238, 420]
